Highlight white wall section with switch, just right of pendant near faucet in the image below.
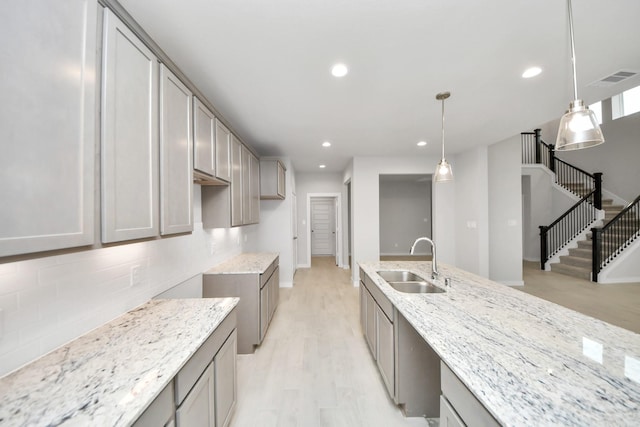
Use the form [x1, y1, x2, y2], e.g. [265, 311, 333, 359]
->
[454, 147, 489, 277]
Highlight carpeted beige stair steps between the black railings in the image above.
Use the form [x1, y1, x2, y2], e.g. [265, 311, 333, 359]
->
[550, 200, 632, 280]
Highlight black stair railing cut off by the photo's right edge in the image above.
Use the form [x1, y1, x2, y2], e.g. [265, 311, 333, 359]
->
[591, 196, 640, 282]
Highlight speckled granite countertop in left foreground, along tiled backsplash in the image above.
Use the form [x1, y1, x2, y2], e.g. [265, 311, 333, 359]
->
[0, 298, 238, 426]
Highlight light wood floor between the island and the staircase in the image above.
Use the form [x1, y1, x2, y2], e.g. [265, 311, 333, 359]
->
[514, 261, 640, 333]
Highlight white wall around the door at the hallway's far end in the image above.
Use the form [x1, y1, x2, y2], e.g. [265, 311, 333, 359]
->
[296, 173, 346, 267]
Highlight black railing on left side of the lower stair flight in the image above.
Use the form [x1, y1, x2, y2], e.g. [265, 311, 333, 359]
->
[539, 190, 601, 270]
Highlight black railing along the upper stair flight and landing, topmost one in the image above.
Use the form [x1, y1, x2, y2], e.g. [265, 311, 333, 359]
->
[520, 129, 602, 209]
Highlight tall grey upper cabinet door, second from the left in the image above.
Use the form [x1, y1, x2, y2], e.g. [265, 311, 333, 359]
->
[101, 9, 160, 243]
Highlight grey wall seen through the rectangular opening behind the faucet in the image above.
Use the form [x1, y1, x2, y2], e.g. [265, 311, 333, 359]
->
[380, 175, 432, 255]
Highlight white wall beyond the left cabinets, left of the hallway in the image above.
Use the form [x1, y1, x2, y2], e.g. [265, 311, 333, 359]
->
[243, 157, 297, 287]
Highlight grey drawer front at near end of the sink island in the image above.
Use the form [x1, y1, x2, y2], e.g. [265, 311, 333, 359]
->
[440, 362, 500, 427]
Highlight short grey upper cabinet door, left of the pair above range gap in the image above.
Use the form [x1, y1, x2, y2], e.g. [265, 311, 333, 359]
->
[193, 97, 215, 176]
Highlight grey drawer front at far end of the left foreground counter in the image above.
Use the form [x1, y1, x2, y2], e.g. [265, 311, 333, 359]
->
[174, 309, 236, 406]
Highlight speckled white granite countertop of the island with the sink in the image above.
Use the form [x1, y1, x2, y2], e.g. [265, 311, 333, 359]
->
[360, 261, 640, 426]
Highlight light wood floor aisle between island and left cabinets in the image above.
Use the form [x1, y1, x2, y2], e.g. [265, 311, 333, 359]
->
[231, 257, 428, 427]
